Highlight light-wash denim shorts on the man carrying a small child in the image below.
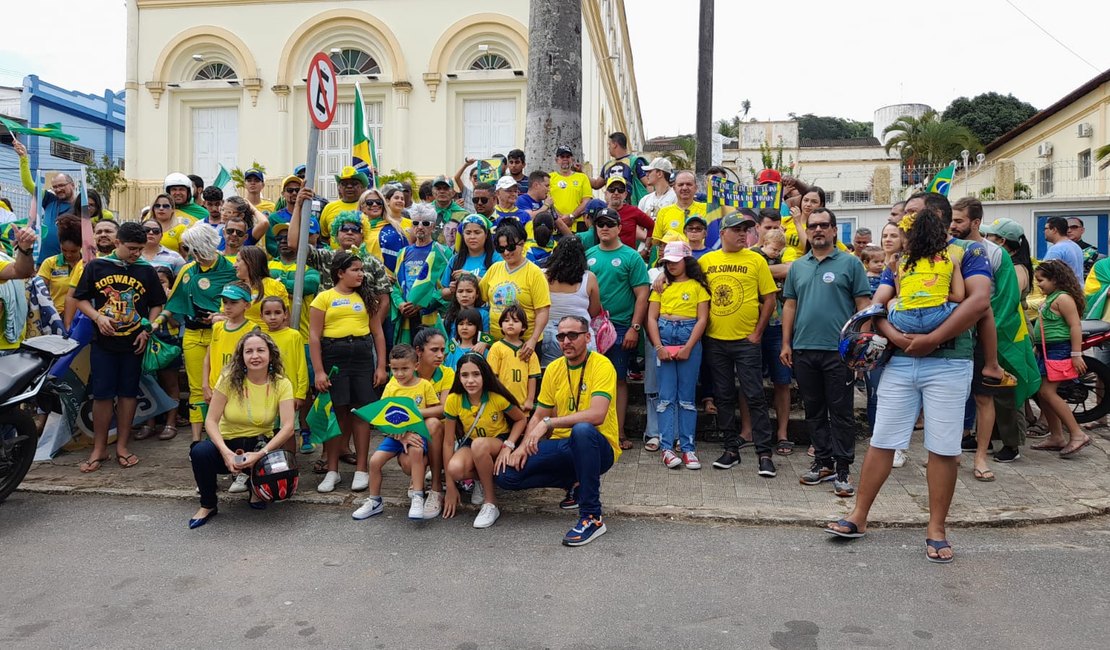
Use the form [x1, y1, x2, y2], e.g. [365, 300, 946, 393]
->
[871, 356, 972, 456]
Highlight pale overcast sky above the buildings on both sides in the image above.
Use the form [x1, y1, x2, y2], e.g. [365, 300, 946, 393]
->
[0, 0, 1110, 138]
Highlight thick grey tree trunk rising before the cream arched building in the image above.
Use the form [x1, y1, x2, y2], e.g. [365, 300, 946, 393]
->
[524, 0, 583, 170]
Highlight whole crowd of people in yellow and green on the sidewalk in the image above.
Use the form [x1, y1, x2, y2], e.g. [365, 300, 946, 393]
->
[0, 133, 1096, 552]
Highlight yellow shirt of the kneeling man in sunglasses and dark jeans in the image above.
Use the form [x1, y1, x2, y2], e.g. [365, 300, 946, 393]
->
[536, 352, 620, 463]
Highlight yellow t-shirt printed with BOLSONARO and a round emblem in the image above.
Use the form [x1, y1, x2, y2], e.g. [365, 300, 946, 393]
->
[698, 248, 778, 341]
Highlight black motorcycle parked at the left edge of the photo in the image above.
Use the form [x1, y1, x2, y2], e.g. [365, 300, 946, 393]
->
[0, 334, 79, 502]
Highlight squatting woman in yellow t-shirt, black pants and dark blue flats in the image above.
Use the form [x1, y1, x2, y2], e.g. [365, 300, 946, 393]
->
[189, 328, 296, 528]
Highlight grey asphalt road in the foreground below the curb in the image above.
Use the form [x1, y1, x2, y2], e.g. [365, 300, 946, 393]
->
[0, 492, 1110, 650]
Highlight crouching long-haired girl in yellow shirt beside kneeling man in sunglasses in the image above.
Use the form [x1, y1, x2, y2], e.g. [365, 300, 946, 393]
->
[443, 353, 527, 528]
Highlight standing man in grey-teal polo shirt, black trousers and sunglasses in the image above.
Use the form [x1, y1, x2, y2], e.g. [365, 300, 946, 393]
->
[779, 207, 871, 497]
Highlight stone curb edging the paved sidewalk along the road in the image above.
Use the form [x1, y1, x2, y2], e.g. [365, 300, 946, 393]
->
[18, 484, 1110, 528]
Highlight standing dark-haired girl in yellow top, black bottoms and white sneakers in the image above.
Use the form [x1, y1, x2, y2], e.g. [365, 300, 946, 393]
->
[308, 251, 389, 492]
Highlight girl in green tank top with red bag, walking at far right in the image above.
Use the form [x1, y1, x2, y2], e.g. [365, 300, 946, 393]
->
[1032, 260, 1091, 458]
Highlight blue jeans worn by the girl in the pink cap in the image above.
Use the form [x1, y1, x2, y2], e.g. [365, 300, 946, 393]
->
[654, 318, 702, 451]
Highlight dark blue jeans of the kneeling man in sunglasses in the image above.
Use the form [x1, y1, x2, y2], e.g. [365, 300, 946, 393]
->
[494, 423, 613, 517]
